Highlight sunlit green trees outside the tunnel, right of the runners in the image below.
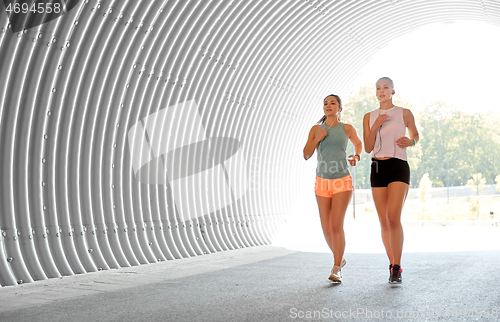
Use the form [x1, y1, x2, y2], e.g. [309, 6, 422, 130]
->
[412, 101, 500, 186]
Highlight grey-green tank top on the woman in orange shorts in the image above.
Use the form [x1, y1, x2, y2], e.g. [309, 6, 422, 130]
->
[316, 122, 350, 179]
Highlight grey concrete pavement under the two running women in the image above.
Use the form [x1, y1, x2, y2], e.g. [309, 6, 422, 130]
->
[0, 220, 500, 322]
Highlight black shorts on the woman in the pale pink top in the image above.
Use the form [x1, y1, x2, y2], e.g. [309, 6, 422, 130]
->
[370, 158, 410, 188]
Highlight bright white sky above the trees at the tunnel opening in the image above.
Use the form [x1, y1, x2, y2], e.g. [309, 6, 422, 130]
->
[352, 21, 500, 113]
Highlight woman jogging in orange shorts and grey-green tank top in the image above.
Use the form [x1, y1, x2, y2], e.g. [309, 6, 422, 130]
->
[304, 94, 363, 283]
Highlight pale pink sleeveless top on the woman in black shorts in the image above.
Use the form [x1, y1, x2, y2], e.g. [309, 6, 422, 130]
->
[370, 106, 407, 161]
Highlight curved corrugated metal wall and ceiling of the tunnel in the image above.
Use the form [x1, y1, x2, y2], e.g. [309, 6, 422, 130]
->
[0, 0, 500, 286]
